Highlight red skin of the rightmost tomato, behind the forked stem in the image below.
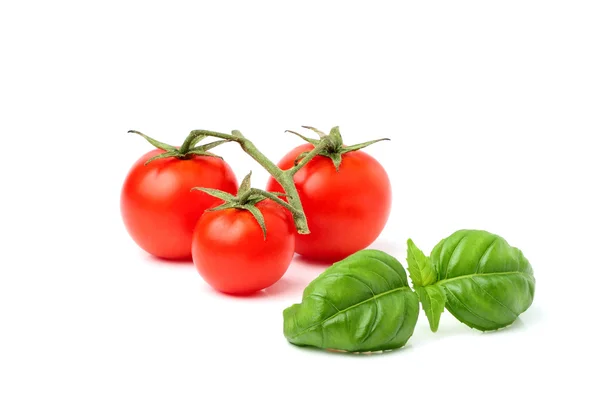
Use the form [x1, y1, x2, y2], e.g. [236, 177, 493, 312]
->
[267, 144, 392, 262]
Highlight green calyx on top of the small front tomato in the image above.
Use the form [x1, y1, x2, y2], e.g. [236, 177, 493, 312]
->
[192, 171, 298, 239]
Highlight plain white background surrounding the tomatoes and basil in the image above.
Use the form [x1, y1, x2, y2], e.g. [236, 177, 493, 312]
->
[0, 1, 600, 393]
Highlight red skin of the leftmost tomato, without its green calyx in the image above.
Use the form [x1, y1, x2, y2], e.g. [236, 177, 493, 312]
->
[121, 149, 238, 259]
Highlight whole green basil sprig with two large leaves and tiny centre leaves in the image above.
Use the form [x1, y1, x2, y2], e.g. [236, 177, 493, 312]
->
[283, 230, 535, 352]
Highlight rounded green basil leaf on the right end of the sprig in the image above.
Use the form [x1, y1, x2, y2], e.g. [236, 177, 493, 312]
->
[430, 230, 535, 331]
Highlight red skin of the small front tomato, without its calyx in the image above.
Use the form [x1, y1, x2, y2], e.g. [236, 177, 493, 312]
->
[192, 200, 296, 295]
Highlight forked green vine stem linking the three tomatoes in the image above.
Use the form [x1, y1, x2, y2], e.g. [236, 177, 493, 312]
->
[190, 130, 330, 234]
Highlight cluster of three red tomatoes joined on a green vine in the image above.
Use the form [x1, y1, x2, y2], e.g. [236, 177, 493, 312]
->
[121, 128, 391, 294]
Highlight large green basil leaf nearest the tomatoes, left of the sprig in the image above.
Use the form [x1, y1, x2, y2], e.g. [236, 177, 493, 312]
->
[283, 250, 419, 352]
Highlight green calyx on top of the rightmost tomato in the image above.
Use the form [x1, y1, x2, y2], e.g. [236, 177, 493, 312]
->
[286, 126, 390, 171]
